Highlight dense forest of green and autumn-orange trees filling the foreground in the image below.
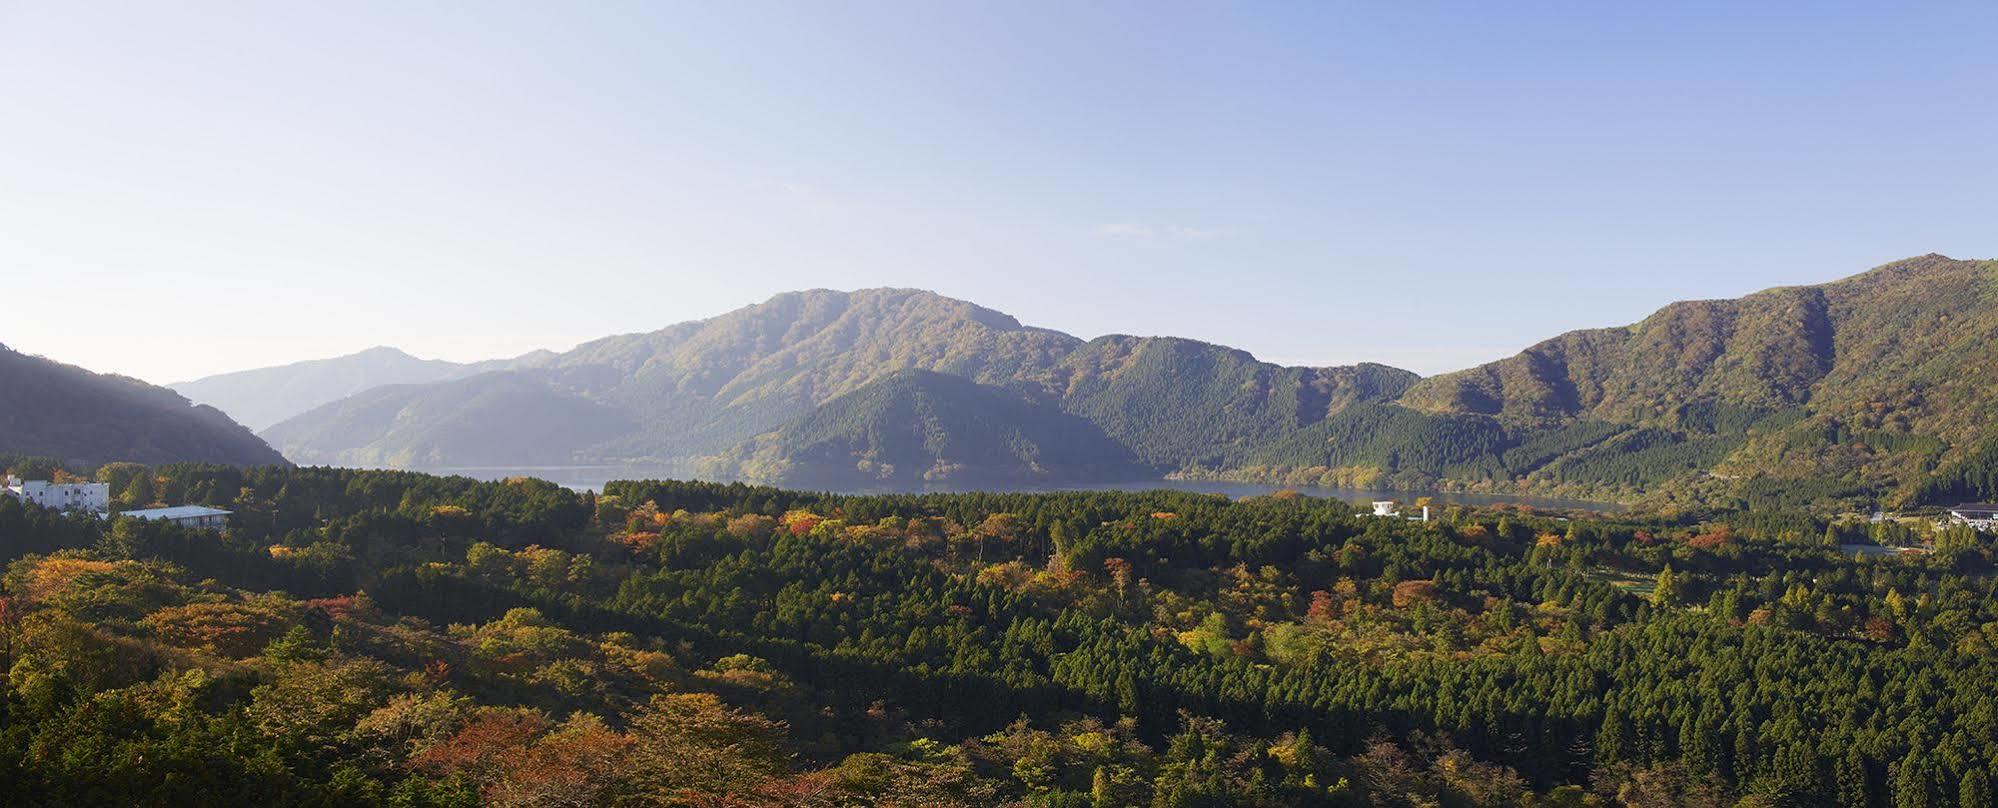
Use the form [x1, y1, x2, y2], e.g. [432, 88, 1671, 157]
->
[0, 464, 1998, 808]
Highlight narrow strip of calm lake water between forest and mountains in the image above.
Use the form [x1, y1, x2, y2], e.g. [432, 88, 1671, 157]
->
[420, 466, 1622, 510]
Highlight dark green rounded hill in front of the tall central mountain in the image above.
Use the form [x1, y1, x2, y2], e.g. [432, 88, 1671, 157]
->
[707, 370, 1147, 488]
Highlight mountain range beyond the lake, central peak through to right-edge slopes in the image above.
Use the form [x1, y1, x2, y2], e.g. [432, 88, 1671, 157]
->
[167, 254, 1998, 506]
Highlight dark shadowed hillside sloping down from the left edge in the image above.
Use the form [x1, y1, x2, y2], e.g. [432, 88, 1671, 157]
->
[0, 346, 284, 468]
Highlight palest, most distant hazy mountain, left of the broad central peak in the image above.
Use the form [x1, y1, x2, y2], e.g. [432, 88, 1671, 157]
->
[168, 348, 535, 430]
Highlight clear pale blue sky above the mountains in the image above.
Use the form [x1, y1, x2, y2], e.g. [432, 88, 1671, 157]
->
[0, 0, 1998, 382]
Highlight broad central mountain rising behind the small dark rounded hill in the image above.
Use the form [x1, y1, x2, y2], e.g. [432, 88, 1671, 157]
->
[264, 290, 1417, 478]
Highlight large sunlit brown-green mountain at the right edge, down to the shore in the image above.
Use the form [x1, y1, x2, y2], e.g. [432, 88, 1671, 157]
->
[1243, 256, 1998, 506]
